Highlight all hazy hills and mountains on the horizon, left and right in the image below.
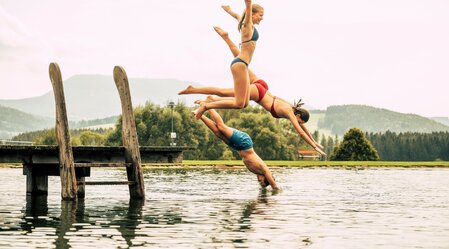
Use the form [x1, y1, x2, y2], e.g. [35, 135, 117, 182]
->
[0, 75, 449, 139]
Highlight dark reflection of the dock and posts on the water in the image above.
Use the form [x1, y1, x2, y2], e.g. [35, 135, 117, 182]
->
[19, 196, 147, 248]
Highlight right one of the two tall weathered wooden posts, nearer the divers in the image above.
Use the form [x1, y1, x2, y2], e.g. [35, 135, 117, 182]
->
[114, 66, 145, 199]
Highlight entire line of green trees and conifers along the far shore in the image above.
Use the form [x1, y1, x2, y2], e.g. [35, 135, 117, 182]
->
[14, 103, 449, 161]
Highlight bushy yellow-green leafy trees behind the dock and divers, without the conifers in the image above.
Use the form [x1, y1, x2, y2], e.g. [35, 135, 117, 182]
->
[14, 102, 324, 160]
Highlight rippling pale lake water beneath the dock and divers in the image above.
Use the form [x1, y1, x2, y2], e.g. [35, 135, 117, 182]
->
[0, 168, 449, 249]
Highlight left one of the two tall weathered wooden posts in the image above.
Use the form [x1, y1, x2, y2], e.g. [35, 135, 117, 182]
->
[49, 63, 78, 200]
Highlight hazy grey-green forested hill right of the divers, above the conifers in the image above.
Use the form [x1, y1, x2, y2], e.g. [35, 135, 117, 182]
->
[318, 105, 449, 135]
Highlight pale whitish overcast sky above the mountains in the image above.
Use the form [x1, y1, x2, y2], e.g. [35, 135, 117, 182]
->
[0, 0, 449, 117]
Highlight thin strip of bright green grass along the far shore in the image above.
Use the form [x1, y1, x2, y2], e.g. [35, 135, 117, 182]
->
[0, 160, 449, 168]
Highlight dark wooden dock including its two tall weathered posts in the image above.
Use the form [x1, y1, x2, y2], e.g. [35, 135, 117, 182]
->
[0, 63, 192, 200]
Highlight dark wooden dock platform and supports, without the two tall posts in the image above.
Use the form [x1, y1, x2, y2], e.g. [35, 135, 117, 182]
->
[0, 145, 192, 197]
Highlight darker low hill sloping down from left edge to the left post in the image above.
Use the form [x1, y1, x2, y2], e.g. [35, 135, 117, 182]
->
[0, 105, 55, 139]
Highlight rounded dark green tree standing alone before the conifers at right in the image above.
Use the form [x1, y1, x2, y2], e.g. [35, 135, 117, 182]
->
[330, 128, 379, 161]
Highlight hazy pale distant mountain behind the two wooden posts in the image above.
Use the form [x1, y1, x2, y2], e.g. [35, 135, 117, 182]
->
[0, 75, 204, 121]
